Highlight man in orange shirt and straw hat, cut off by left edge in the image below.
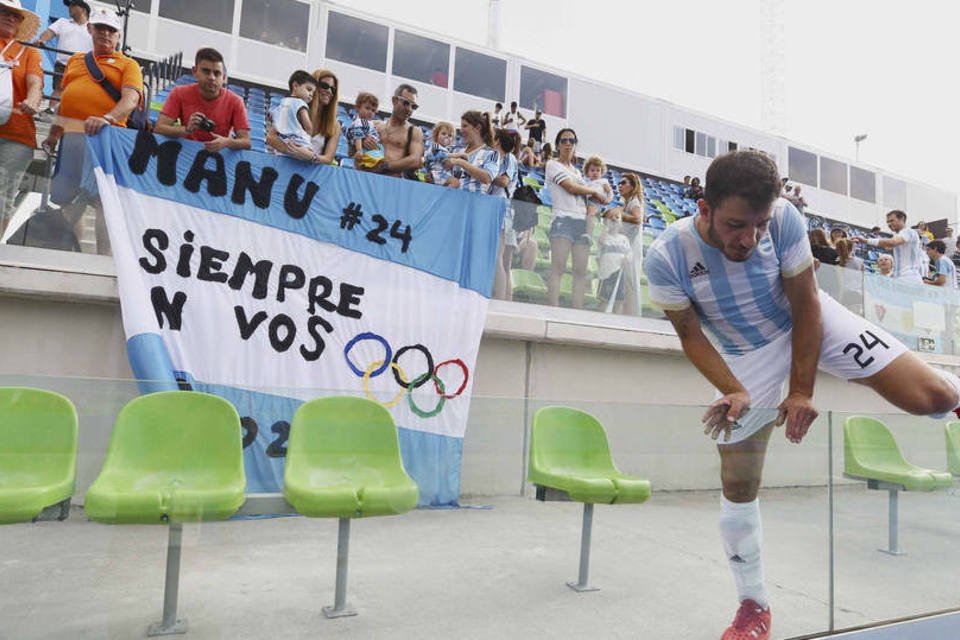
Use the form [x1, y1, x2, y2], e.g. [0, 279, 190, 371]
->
[0, 0, 43, 236]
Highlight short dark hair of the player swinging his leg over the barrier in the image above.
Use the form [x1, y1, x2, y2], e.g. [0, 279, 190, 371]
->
[703, 150, 780, 209]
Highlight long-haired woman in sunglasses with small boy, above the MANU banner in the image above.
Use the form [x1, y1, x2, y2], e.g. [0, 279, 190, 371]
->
[266, 69, 340, 164]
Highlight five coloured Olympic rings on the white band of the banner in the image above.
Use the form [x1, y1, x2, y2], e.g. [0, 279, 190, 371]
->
[343, 331, 470, 418]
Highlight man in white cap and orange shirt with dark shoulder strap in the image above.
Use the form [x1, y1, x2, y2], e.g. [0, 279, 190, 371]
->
[43, 9, 143, 255]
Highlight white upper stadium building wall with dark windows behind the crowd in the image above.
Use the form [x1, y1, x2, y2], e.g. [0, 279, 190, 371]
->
[110, 0, 958, 227]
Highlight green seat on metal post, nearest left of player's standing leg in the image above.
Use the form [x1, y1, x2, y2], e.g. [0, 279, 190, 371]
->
[527, 407, 650, 591]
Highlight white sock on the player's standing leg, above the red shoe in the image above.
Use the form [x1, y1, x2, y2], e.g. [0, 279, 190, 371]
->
[720, 493, 768, 607]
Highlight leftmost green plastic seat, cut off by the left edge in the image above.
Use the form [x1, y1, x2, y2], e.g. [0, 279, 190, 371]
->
[0, 387, 77, 524]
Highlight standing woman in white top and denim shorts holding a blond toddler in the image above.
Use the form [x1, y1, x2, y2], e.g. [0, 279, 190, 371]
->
[546, 128, 605, 309]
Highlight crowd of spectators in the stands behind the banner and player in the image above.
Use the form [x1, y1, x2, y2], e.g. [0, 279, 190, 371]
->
[0, 0, 960, 314]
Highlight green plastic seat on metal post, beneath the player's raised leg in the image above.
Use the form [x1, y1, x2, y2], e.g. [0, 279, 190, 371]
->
[843, 416, 953, 555]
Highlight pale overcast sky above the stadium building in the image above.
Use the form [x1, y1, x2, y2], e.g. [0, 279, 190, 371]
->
[335, 0, 960, 198]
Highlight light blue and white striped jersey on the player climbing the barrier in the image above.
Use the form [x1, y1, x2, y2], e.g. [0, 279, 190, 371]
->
[644, 198, 813, 355]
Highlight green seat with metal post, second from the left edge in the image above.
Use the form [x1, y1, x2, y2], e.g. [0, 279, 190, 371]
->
[84, 391, 246, 636]
